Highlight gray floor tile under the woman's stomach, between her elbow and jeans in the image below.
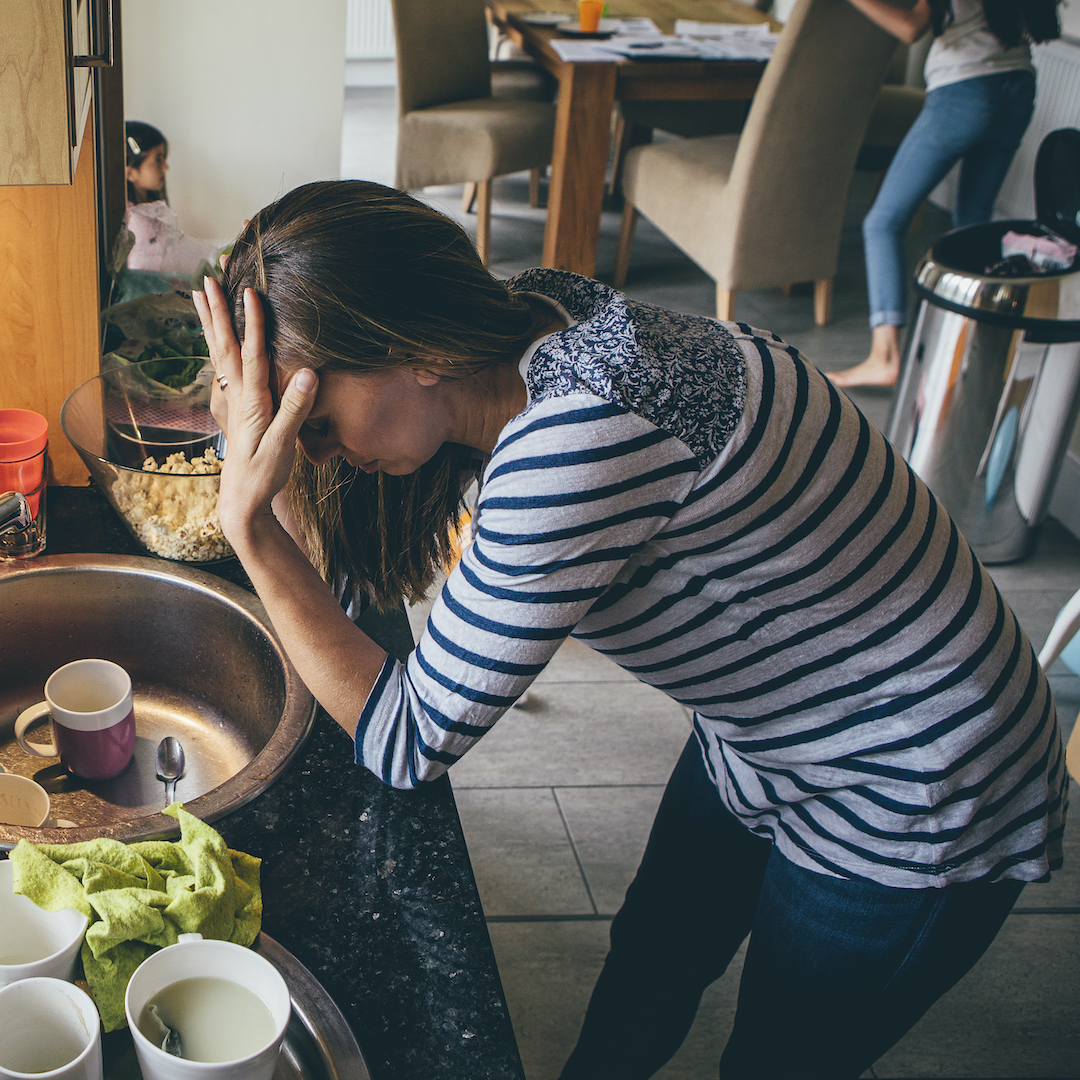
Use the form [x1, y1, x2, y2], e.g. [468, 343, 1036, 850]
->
[451, 681, 690, 789]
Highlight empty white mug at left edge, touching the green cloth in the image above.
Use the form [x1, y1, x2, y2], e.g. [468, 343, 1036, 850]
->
[0, 859, 90, 986]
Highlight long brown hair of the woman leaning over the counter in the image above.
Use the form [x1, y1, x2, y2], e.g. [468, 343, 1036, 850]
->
[225, 180, 551, 608]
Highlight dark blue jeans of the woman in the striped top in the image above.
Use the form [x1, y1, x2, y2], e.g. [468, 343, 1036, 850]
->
[562, 738, 1023, 1080]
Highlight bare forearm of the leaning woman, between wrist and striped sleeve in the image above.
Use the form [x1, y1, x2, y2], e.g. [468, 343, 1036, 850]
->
[230, 514, 387, 735]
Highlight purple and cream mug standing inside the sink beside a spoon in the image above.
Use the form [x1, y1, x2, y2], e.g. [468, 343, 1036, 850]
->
[15, 660, 135, 780]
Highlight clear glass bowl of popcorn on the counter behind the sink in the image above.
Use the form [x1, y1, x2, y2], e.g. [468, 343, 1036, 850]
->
[60, 356, 233, 564]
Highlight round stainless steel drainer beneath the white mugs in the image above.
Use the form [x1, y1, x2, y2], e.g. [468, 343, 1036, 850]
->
[102, 934, 370, 1080]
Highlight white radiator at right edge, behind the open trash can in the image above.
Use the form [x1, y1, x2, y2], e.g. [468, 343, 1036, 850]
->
[995, 41, 1080, 218]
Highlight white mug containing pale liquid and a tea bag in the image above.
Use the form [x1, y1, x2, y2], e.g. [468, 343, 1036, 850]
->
[124, 934, 293, 1080]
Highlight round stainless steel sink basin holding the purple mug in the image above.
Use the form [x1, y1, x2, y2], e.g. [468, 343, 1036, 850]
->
[0, 555, 315, 850]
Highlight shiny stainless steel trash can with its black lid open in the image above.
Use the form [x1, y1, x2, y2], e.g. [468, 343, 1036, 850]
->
[886, 129, 1080, 564]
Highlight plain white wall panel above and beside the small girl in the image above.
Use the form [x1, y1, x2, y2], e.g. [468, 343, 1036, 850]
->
[123, 0, 346, 241]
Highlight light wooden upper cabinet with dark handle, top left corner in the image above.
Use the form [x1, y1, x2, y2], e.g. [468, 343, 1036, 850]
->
[0, 0, 100, 185]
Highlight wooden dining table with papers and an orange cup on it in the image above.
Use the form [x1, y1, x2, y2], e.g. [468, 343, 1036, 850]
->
[487, 0, 780, 278]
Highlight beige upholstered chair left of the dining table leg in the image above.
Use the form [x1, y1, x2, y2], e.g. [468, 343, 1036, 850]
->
[393, 0, 555, 262]
